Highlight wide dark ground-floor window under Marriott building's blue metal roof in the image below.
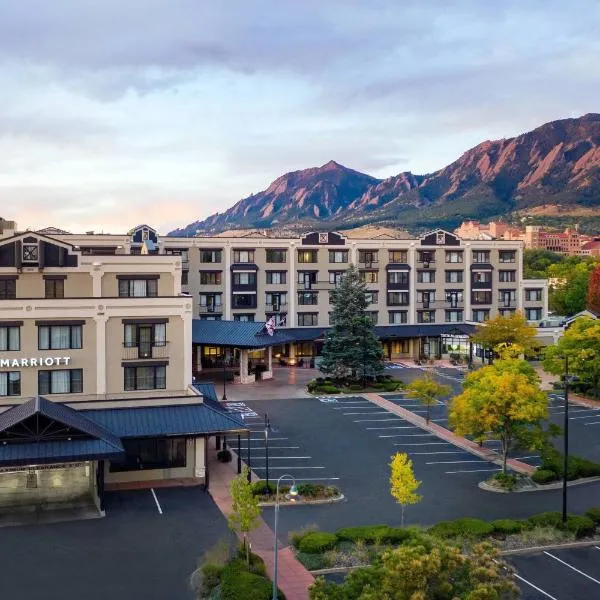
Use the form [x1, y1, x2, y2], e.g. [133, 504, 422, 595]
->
[109, 438, 187, 473]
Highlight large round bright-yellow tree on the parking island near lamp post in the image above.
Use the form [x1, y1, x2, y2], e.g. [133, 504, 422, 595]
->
[450, 358, 548, 473]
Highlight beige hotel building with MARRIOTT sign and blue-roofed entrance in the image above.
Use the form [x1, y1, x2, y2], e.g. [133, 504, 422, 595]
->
[0, 230, 246, 515]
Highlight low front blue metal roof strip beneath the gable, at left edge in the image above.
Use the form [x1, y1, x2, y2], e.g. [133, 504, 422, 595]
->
[0, 439, 123, 465]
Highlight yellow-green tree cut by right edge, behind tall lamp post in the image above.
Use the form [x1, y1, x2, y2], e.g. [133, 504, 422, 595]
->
[543, 317, 600, 397]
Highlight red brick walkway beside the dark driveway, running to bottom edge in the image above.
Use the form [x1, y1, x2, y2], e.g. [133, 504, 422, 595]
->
[208, 453, 314, 600]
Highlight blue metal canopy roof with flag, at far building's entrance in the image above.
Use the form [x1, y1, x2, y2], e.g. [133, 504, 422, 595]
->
[192, 319, 292, 348]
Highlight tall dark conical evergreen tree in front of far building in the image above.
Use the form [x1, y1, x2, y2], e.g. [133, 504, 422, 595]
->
[319, 265, 385, 380]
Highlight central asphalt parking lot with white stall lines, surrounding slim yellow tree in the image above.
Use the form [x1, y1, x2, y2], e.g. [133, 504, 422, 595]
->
[226, 396, 600, 540]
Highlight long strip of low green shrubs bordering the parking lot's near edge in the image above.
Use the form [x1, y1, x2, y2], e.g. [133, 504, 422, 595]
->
[290, 507, 600, 571]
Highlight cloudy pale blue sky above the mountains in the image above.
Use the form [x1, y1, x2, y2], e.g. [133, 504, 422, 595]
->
[0, 0, 600, 233]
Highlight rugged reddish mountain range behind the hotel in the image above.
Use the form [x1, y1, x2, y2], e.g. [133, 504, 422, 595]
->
[169, 113, 600, 236]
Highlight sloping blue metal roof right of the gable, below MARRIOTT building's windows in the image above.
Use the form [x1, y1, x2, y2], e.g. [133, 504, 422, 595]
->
[81, 404, 247, 438]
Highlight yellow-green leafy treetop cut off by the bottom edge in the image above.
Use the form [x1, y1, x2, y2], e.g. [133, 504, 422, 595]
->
[309, 538, 519, 600]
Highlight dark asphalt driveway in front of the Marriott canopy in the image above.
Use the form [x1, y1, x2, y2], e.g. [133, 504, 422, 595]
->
[0, 488, 230, 600]
